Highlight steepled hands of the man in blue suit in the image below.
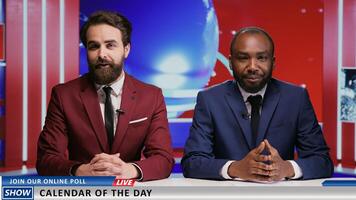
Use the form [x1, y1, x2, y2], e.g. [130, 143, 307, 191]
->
[228, 139, 294, 182]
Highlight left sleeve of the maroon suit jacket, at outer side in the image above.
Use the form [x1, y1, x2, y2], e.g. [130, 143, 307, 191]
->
[36, 86, 80, 176]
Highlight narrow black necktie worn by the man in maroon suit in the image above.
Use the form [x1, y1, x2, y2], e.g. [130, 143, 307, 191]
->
[103, 86, 114, 150]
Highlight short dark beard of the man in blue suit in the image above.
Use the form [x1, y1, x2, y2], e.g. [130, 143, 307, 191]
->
[233, 70, 272, 93]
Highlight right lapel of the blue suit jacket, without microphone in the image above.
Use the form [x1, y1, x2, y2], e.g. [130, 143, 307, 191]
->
[256, 79, 280, 145]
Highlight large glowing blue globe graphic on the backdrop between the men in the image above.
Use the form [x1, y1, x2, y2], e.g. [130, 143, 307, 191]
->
[80, 0, 219, 118]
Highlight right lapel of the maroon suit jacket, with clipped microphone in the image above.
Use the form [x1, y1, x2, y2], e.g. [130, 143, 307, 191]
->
[112, 74, 136, 153]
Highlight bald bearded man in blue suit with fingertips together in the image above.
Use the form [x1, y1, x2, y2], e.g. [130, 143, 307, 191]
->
[181, 27, 333, 182]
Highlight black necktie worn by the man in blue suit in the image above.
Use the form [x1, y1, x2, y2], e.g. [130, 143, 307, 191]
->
[247, 95, 262, 146]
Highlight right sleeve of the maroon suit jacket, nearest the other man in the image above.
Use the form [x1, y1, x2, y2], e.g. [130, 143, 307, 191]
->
[135, 90, 174, 181]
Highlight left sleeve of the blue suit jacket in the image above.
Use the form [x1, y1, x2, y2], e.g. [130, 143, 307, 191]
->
[181, 92, 228, 179]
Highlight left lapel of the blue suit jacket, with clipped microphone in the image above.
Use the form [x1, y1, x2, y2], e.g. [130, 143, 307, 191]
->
[225, 81, 254, 149]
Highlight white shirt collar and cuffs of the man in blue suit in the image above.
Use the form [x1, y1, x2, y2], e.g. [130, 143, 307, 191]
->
[220, 83, 303, 180]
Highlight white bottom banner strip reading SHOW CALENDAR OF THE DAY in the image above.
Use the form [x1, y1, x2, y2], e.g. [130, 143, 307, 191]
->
[2, 186, 356, 200]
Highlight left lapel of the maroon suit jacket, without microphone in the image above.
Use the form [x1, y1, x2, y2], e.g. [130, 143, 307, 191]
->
[80, 75, 109, 152]
